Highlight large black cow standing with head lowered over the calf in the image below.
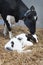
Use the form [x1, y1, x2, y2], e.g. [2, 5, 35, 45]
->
[0, 0, 37, 38]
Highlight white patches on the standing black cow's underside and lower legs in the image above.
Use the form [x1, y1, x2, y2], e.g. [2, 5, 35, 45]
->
[3, 15, 15, 38]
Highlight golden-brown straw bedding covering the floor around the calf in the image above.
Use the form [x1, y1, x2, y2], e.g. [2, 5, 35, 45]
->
[0, 26, 43, 65]
